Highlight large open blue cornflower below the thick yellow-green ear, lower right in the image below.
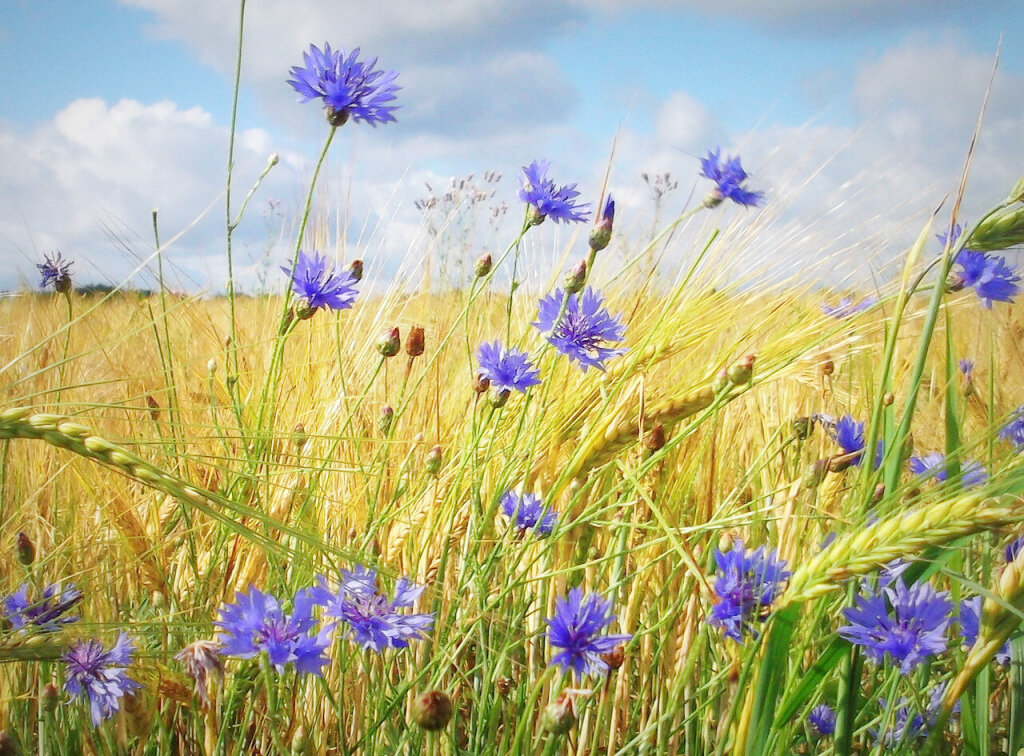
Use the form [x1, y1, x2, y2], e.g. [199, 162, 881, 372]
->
[839, 579, 952, 674]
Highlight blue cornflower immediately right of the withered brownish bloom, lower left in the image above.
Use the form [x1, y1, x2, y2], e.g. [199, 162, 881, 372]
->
[213, 587, 334, 674]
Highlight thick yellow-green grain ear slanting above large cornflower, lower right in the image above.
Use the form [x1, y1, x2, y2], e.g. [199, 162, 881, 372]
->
[779, 494, 1024, 608]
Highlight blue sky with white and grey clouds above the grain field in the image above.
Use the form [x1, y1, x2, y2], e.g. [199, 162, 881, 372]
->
[0, 0, 1024, 293]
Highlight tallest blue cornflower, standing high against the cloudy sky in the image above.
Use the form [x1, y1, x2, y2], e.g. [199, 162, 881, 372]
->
[288, 44, 400, 127]
